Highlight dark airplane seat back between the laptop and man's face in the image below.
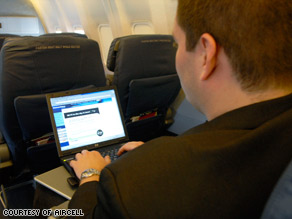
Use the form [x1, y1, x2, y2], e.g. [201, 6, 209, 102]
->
[107, 35, 181, 141]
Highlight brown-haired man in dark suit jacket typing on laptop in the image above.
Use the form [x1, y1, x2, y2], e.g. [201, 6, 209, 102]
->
[69, 0, 292, 219]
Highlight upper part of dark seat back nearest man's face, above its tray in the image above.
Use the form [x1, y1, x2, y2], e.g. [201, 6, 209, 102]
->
[107, 35, 176, 113]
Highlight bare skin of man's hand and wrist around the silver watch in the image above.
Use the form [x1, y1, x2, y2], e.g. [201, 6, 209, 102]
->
[70, 150, 111, 185]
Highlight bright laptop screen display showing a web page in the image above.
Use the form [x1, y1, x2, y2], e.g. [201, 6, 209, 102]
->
[50, 90, 125, 151]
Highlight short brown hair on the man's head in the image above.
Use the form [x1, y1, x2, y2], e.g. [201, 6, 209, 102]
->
[177, 0, 292, 92]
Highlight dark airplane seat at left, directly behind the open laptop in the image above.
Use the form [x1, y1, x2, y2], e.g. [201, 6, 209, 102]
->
[0, 36, 106, 176]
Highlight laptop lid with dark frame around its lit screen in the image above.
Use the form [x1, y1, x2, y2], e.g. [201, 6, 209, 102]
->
[46, 86, 128, 157]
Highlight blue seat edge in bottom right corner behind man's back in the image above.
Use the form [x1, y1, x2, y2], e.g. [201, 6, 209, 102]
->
[261, 160, 292, 219]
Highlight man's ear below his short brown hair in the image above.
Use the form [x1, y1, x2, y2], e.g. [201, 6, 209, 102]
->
[199, 33, 217, 80]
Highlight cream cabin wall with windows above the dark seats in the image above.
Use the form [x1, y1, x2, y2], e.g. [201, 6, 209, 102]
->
[31, 0, 177, 63]
